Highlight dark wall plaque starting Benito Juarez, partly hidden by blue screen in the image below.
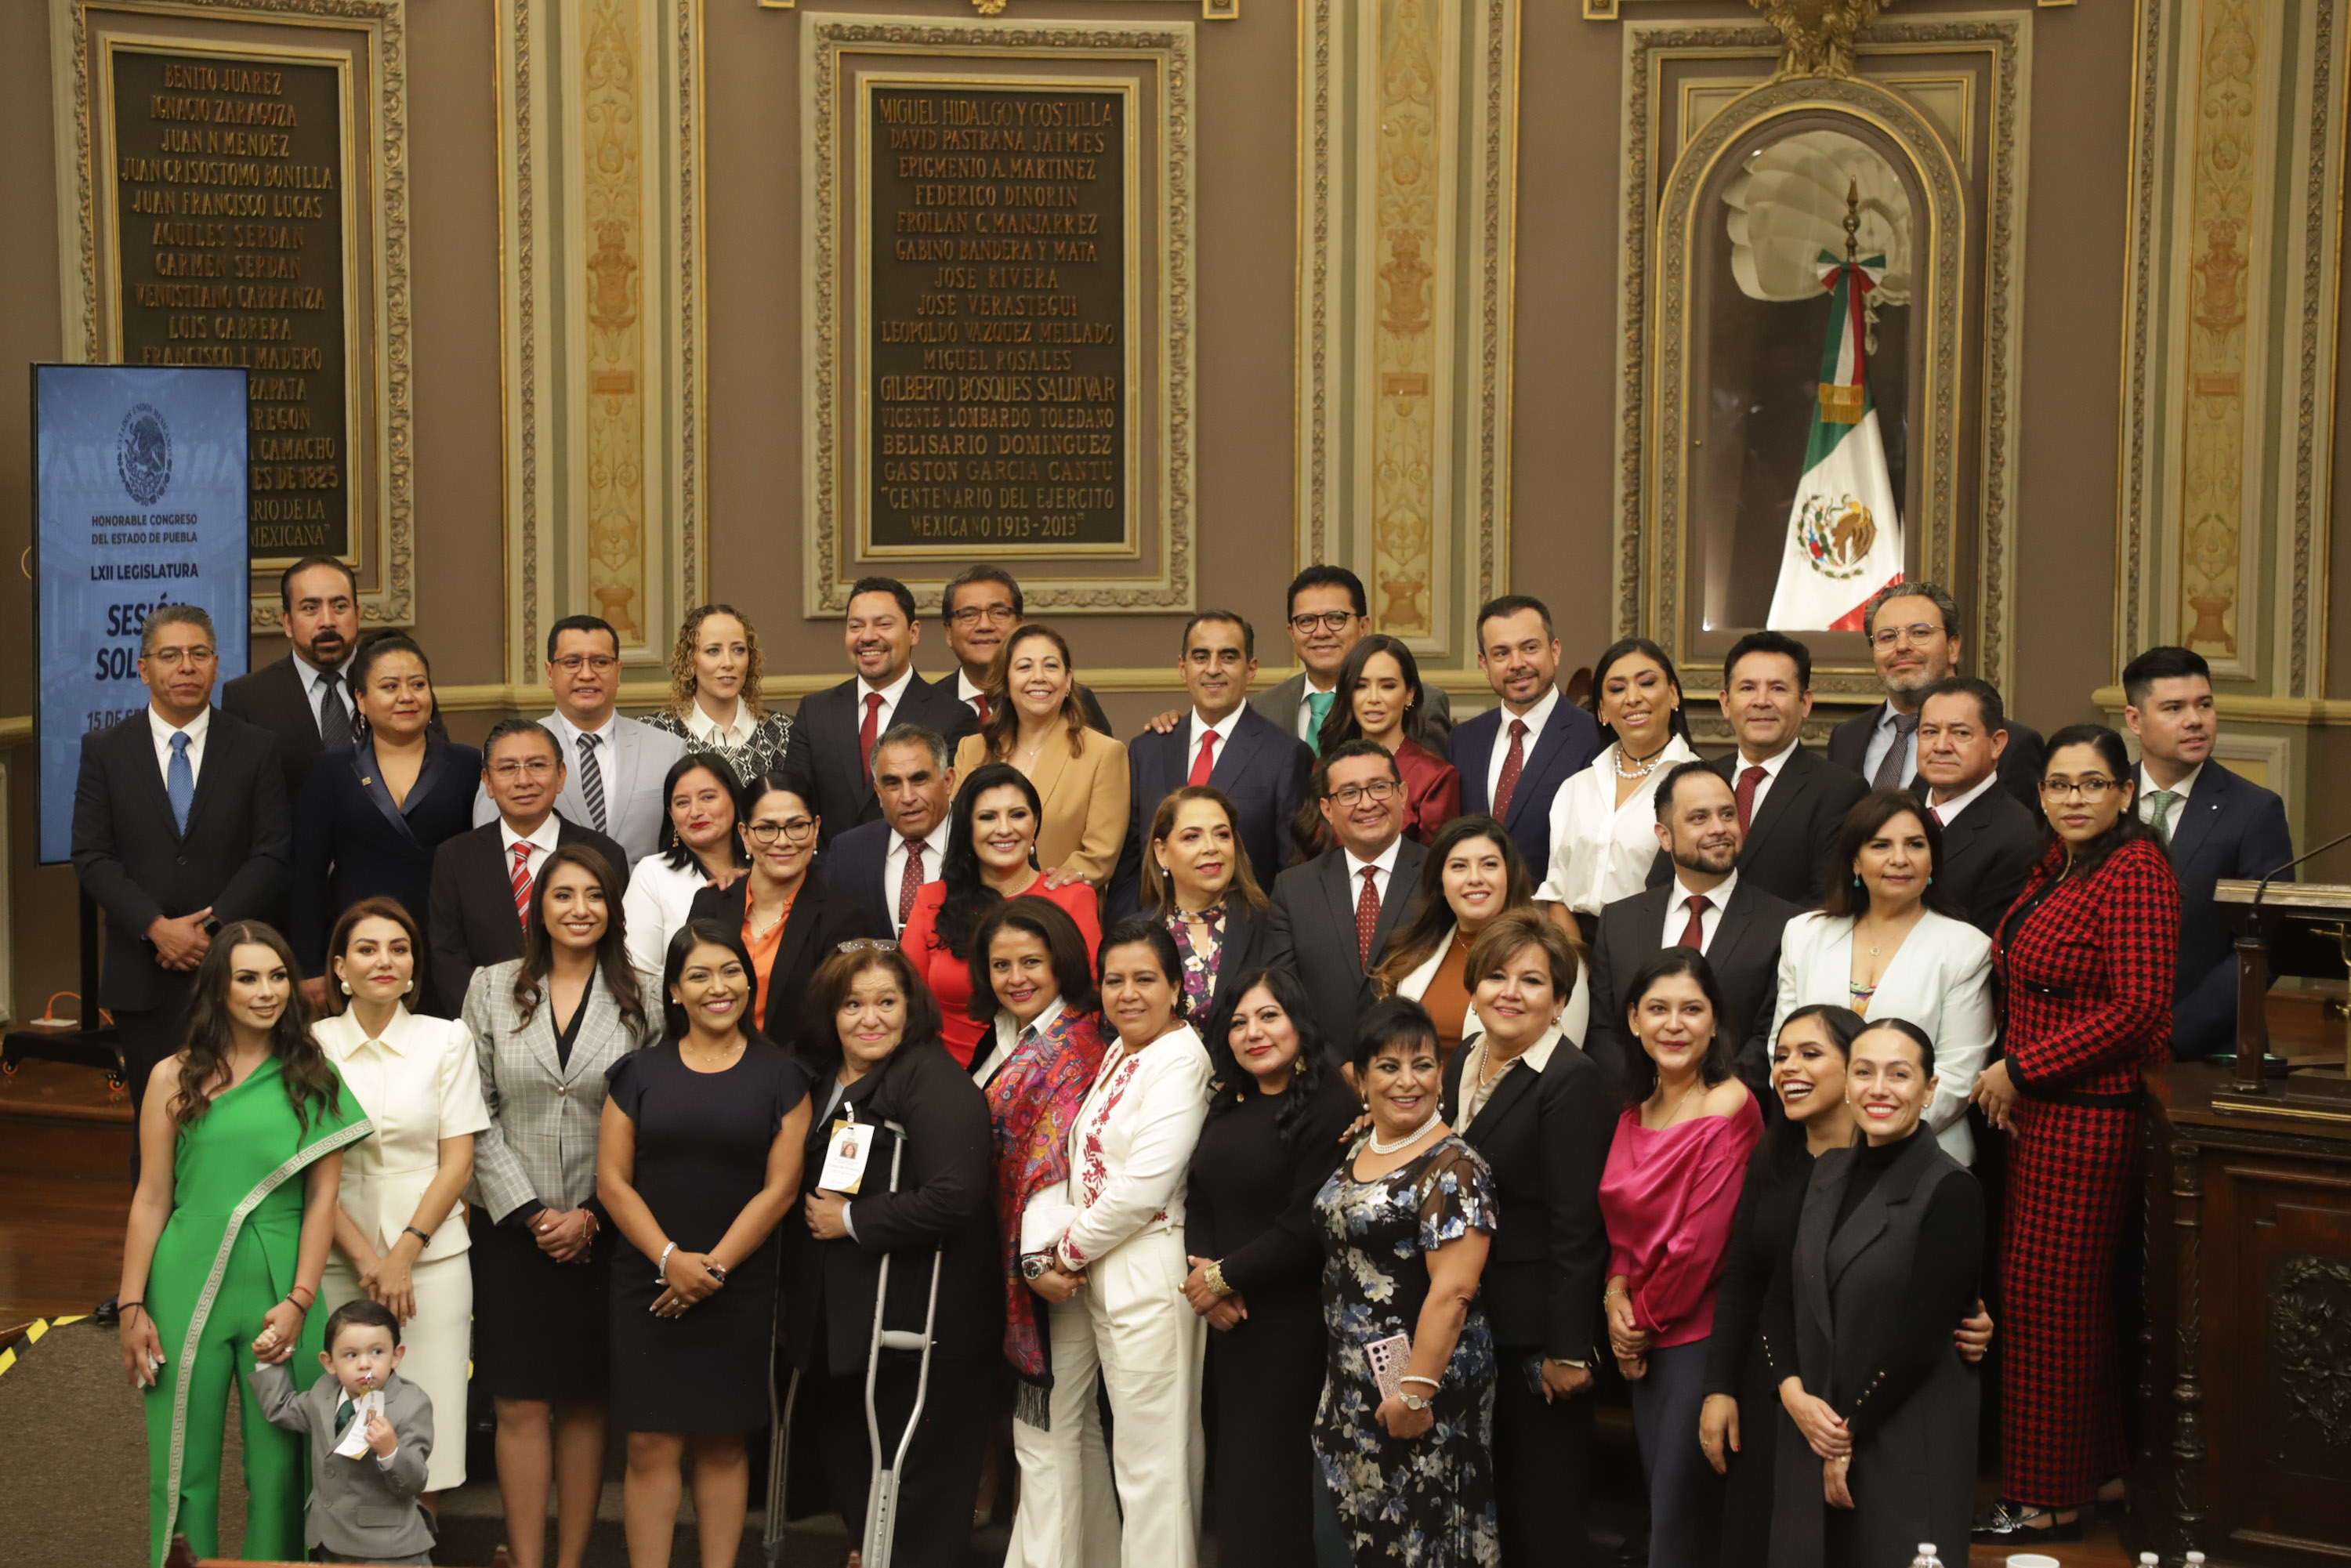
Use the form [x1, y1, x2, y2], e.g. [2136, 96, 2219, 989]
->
[106, 45, 355, 562]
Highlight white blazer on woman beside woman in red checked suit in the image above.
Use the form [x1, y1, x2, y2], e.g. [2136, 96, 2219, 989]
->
[1770, 910, 1998, 1166]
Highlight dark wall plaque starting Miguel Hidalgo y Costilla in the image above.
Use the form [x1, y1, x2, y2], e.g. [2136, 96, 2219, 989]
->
[863, 82, 1136, 557]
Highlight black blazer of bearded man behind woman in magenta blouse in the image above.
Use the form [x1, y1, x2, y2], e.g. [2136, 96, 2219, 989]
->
[1585, 879, 1803, 1095]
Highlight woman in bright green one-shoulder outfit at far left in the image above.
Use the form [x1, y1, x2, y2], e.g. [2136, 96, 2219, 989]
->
[118, 922, 371, 1563]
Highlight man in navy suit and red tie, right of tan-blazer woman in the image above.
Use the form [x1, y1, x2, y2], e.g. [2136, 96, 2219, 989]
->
[1110, 609, 1314, 919]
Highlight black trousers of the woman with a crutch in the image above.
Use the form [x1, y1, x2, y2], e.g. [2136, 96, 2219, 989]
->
[792, 1352, 997, 1568]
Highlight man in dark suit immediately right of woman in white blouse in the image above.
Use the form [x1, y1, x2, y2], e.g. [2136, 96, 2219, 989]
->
[1648, 632, 1869, 910]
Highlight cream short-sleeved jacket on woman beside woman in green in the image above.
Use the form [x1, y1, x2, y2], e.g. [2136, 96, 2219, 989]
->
[310, 1009, 489, 1260]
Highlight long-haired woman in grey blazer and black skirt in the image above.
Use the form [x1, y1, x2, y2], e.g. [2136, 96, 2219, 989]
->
[465, 844, 661, 1568]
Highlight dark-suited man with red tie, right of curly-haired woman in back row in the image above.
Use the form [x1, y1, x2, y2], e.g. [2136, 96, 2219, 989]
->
[785, 576, 978, 849]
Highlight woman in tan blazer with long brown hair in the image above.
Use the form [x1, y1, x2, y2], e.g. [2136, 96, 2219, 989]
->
[950, 623, 1128, 884]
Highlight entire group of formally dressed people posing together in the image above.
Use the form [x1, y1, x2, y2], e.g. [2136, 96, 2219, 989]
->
[75, 559, 2292, 1568]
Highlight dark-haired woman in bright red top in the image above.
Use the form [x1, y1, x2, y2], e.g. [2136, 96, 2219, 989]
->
[898, 762, 1100, 1067]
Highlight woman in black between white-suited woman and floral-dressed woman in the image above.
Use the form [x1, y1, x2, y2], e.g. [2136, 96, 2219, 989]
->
[1183, 969, 1357, 1568]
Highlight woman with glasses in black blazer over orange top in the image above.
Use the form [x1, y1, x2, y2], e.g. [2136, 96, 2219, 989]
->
[689, 773, 889, 1051]
